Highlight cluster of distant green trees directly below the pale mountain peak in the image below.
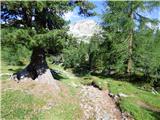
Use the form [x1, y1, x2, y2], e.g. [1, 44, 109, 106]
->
[63, 35, 103, 73]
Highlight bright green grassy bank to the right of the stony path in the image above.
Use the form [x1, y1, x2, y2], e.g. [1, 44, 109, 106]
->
[108, 79, 160, 120]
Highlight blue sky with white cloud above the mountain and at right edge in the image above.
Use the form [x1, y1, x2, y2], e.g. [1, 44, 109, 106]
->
[64, 0, 160, 28]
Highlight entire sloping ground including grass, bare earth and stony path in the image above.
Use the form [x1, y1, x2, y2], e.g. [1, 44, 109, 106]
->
[1, 62, 160, 120]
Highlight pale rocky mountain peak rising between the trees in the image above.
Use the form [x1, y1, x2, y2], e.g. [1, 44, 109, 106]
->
[68, 20, 100, 42]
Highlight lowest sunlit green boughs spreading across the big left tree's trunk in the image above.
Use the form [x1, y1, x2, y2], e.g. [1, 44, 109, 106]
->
[2, 28, 69, 52]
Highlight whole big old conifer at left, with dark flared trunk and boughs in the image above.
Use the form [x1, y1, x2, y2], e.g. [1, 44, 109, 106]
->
[1, 1, 95, 88]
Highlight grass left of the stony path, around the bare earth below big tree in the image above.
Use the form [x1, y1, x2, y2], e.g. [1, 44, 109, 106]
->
[1, 62, 82, 120]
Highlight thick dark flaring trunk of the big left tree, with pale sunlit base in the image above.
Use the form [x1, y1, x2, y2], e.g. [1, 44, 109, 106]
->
[13, 47, 59, 89]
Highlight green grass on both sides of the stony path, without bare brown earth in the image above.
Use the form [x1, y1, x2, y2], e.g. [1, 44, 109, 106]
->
[1, 60, 160, 120]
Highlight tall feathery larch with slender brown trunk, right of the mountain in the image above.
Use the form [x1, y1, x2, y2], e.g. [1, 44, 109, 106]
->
[103, 1, 160, 76]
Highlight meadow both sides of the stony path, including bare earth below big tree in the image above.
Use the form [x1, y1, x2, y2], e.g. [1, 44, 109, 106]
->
[1, 59, 160, 120]
